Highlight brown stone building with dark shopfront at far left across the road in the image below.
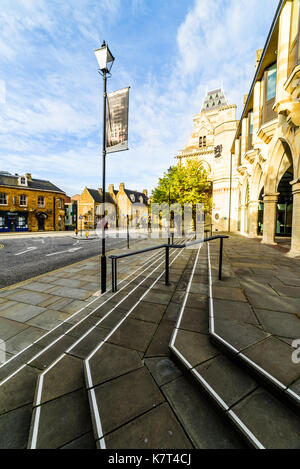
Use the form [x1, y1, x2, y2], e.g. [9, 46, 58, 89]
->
[0, 171, 66, 232]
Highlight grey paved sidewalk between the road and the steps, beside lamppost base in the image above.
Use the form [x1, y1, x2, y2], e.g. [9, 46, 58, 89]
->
[0, 240, 155, 362]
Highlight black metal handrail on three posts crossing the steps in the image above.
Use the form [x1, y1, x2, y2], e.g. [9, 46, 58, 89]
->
[109, 235, 229, 292]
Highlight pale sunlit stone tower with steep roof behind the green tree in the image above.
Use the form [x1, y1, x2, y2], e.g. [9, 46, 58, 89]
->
[177, 89, 238, 231]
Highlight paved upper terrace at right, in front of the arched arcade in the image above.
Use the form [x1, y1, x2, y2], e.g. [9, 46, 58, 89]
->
[212, 235, 300, 403]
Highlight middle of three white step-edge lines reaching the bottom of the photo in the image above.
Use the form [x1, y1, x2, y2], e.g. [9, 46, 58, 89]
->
[84, 234, 192, 449]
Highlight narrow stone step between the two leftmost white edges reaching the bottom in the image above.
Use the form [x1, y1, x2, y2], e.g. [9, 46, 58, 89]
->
[28, 239, 192, 449]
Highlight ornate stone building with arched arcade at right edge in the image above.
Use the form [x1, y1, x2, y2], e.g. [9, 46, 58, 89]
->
[230, 0, 300, 256]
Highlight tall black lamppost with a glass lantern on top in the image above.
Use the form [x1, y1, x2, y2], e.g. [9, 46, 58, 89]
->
[94, 41, 115, 293]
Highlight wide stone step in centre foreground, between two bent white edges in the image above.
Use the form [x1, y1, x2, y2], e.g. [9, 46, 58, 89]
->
[86, 243, 250, 449]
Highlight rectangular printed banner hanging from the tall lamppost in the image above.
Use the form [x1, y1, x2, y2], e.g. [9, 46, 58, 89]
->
[106, 87, 129, 153]
